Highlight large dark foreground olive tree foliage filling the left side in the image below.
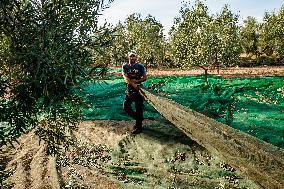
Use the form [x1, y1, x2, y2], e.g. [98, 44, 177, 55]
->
[0, 0, 114, 153]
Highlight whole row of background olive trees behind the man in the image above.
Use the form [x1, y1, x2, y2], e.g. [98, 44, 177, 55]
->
[97, 0, 284, 69]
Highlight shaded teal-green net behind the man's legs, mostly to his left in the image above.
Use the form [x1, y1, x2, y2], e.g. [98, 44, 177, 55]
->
[81, 77, 160, 120]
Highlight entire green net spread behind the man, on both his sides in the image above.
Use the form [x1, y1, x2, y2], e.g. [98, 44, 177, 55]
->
[80, 75, 284, 148]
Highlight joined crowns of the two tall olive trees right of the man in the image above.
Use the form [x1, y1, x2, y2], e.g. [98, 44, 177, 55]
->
[171, 0, 241, 74]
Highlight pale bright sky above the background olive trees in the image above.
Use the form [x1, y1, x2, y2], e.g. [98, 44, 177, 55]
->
[99, 0, 284, 34]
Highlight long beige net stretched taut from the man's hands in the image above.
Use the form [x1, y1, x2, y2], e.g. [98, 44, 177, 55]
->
[141, 89, 284, 188]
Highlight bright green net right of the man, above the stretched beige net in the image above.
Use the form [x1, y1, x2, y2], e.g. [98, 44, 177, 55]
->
[148, 76, 284, 148]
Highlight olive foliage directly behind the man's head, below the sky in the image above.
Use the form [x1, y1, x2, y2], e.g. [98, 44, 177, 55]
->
[91, 14, 168, 66]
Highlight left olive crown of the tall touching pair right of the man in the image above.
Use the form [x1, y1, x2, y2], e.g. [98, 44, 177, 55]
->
[170, 1, 212, 71]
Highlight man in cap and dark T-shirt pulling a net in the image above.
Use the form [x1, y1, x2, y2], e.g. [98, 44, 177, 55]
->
[122, 50, 147, 134]
